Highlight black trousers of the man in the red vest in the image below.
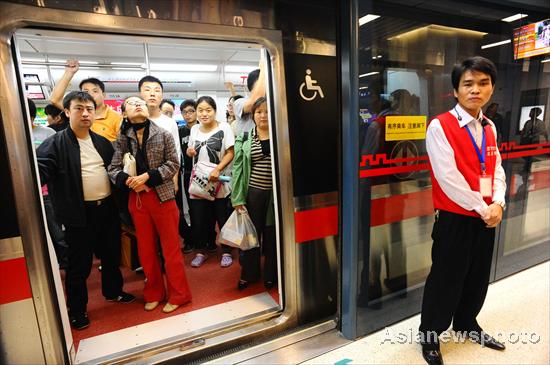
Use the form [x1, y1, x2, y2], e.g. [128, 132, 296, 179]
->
[420, 211, 495, 349]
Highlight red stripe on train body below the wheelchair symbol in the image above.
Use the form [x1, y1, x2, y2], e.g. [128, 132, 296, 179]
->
[294, 205, 338, 243]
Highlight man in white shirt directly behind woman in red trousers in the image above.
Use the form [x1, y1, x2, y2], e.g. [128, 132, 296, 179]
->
[138, 76, 182, 191]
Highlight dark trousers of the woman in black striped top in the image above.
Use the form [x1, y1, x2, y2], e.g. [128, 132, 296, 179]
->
[239, 187, 277, 282]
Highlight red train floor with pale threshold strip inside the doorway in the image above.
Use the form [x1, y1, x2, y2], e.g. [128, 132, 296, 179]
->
[61, 248, 279, 363]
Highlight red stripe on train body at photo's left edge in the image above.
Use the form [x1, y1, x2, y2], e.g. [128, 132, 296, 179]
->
[0, 257, 32, 304]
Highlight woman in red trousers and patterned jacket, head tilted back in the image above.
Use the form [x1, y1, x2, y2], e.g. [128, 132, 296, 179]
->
[109, 96, 191, 313]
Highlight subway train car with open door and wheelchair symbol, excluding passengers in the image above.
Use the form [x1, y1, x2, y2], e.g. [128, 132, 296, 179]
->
[0, 1, 339, 364]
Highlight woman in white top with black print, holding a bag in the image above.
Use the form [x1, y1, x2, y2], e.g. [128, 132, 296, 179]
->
[186, 96, 235, 267]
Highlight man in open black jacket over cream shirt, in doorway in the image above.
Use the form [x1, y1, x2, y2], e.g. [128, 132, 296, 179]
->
[36, 91, 135, 329]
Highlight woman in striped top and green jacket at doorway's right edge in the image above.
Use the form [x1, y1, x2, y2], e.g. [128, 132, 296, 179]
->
[231, 97, 277, 290]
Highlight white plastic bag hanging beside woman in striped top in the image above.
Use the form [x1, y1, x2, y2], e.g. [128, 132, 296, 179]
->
[220, 209, 260, 251]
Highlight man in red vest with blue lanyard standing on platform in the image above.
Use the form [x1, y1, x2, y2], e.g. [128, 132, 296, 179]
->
[420, 56, 506, 364]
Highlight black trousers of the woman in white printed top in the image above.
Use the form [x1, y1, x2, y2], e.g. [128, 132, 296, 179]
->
[189, 198, 232, 253]
